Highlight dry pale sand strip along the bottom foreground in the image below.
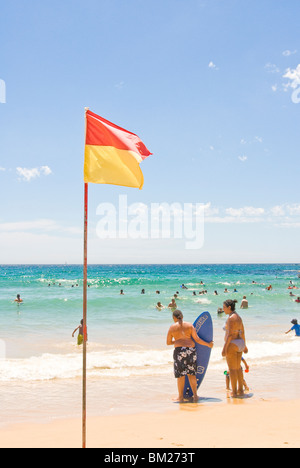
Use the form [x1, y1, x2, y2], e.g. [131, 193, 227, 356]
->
[0, 400, 300, 449]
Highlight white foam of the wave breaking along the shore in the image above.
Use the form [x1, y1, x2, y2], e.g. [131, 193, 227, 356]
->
[0, 338, 300, 382]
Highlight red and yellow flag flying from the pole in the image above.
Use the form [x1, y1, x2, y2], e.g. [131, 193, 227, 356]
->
[84, 110, 152, 190]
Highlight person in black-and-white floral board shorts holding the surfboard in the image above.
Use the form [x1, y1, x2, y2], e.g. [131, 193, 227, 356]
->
[167, 310, 214, 403]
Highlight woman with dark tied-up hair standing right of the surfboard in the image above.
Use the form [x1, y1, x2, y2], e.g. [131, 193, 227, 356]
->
[222, 299, 248, 398]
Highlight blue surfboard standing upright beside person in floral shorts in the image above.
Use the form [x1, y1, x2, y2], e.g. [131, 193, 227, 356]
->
[184, 312, 214, 398]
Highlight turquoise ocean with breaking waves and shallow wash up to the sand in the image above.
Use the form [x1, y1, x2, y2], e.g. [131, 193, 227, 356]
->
[0, 264, 300, 425]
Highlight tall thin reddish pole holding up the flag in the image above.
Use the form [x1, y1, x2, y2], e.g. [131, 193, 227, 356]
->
[82, 108, 89, 449]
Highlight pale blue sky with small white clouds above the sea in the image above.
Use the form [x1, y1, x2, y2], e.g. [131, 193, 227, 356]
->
[0, 0, 300, 264]
